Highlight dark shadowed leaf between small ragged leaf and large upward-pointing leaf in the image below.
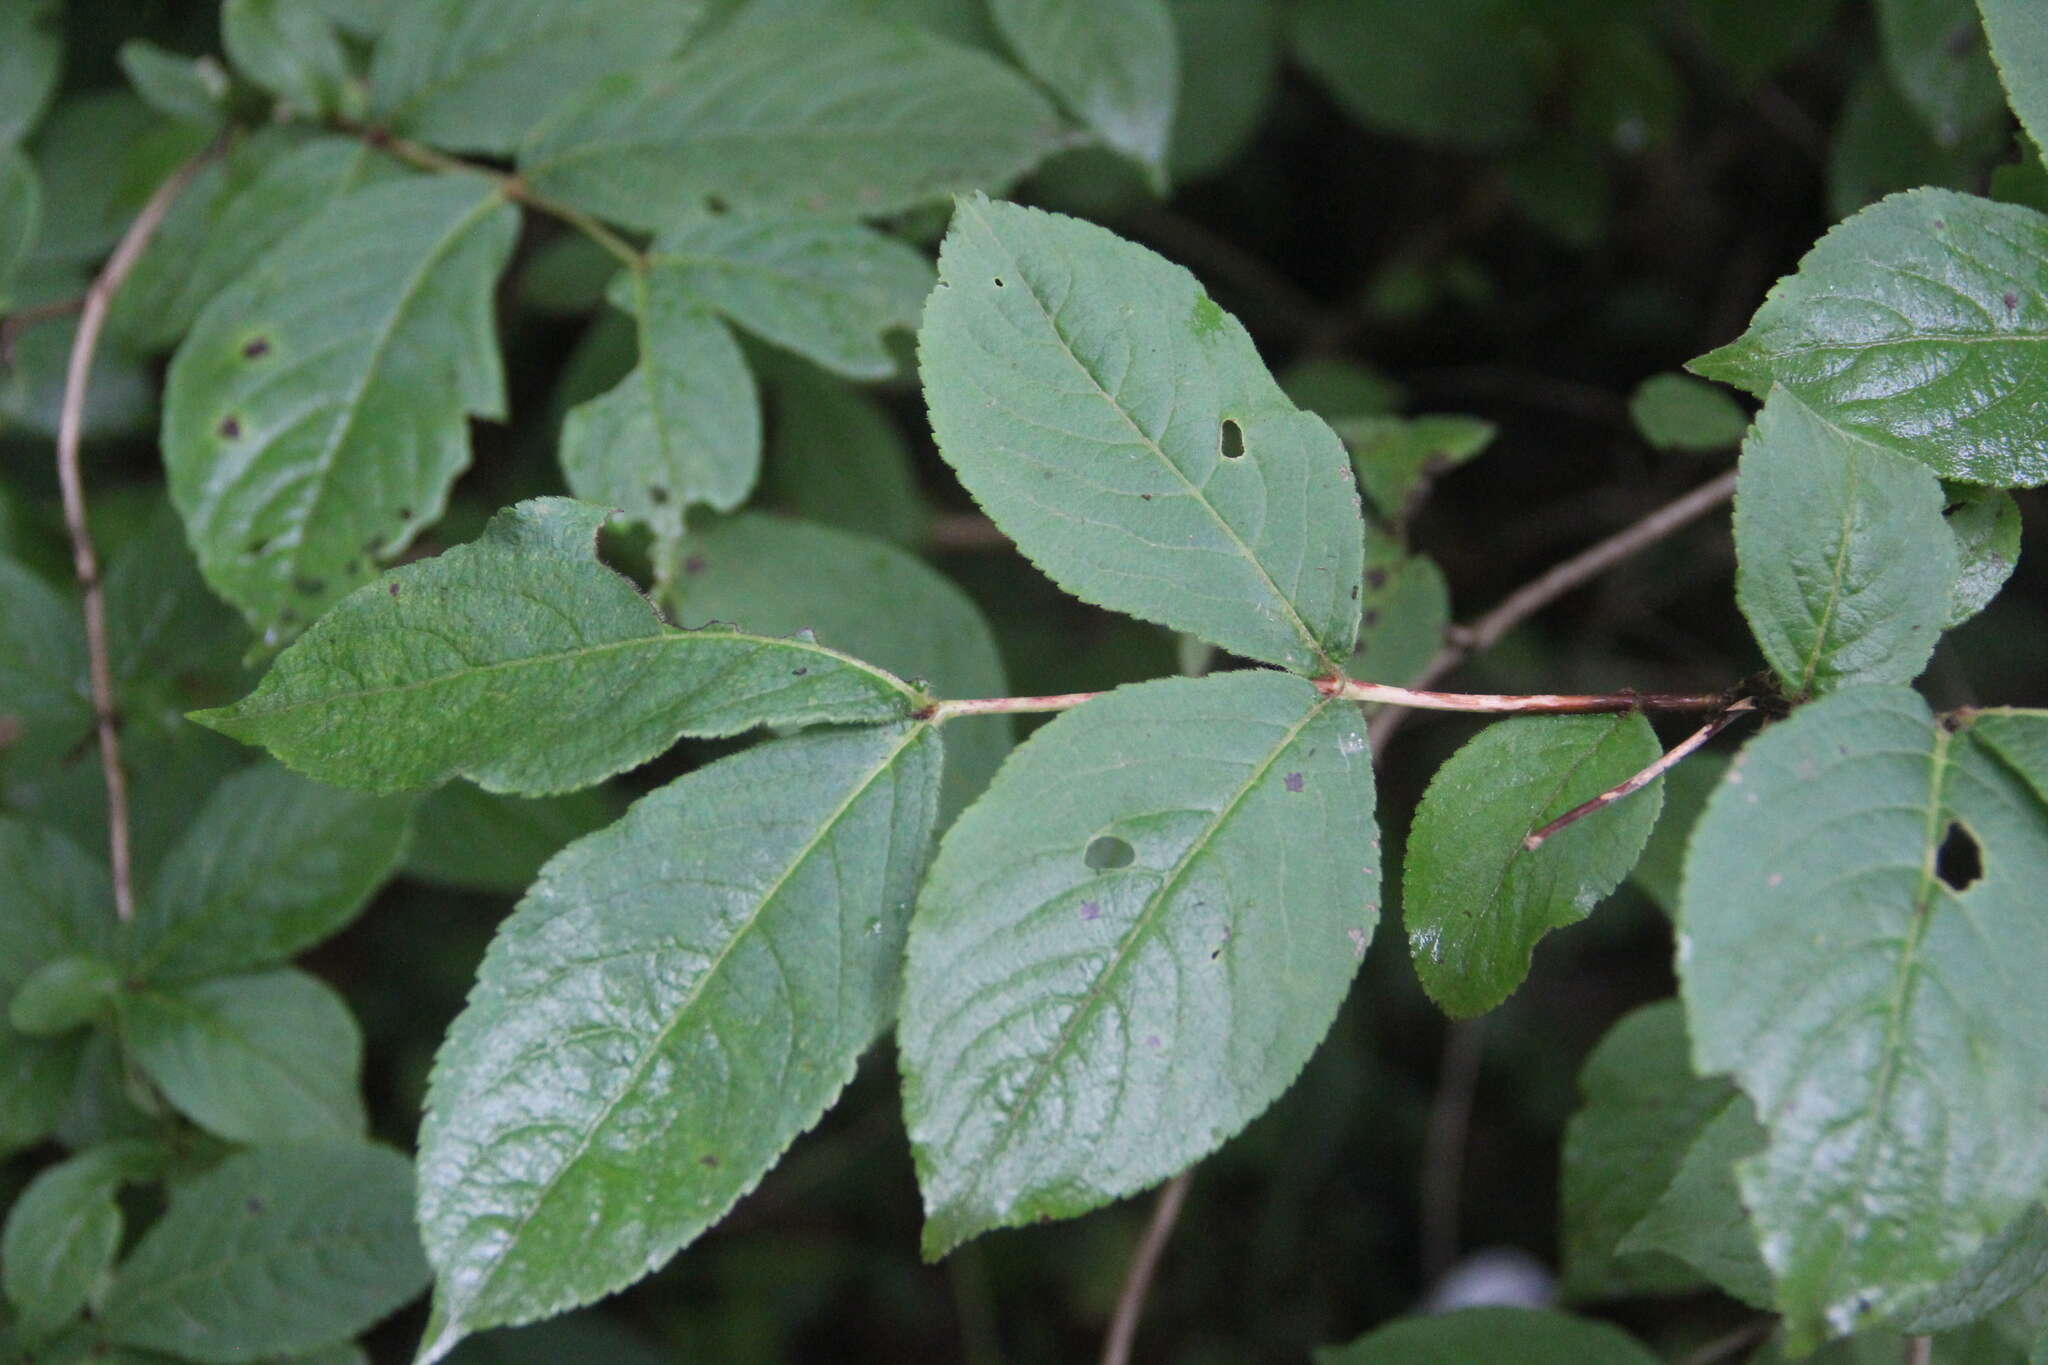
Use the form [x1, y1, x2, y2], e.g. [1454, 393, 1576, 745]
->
[762, 362, 932, 548]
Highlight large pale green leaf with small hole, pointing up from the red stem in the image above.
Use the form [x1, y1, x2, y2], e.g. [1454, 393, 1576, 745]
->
[918, 199, 1364, 673]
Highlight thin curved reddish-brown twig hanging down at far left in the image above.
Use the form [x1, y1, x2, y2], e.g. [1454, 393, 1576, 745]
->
[57, 141, 225, 923]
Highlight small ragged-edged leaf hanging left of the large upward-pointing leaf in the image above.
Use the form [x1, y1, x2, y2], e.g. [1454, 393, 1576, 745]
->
[561, 270, 762, 540]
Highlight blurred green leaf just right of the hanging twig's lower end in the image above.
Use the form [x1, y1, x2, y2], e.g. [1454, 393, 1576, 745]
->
[129, 763, 414, 980]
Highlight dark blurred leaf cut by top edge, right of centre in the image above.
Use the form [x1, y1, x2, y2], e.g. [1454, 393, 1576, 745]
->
[1288, 0, 1546, 147]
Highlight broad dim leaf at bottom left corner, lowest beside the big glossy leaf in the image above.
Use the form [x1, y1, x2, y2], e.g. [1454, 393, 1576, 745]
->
[98, 1142, 426, 1365]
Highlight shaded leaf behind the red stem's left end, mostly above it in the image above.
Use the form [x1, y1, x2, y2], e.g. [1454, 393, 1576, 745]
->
[674, 514, 1012, 823]
